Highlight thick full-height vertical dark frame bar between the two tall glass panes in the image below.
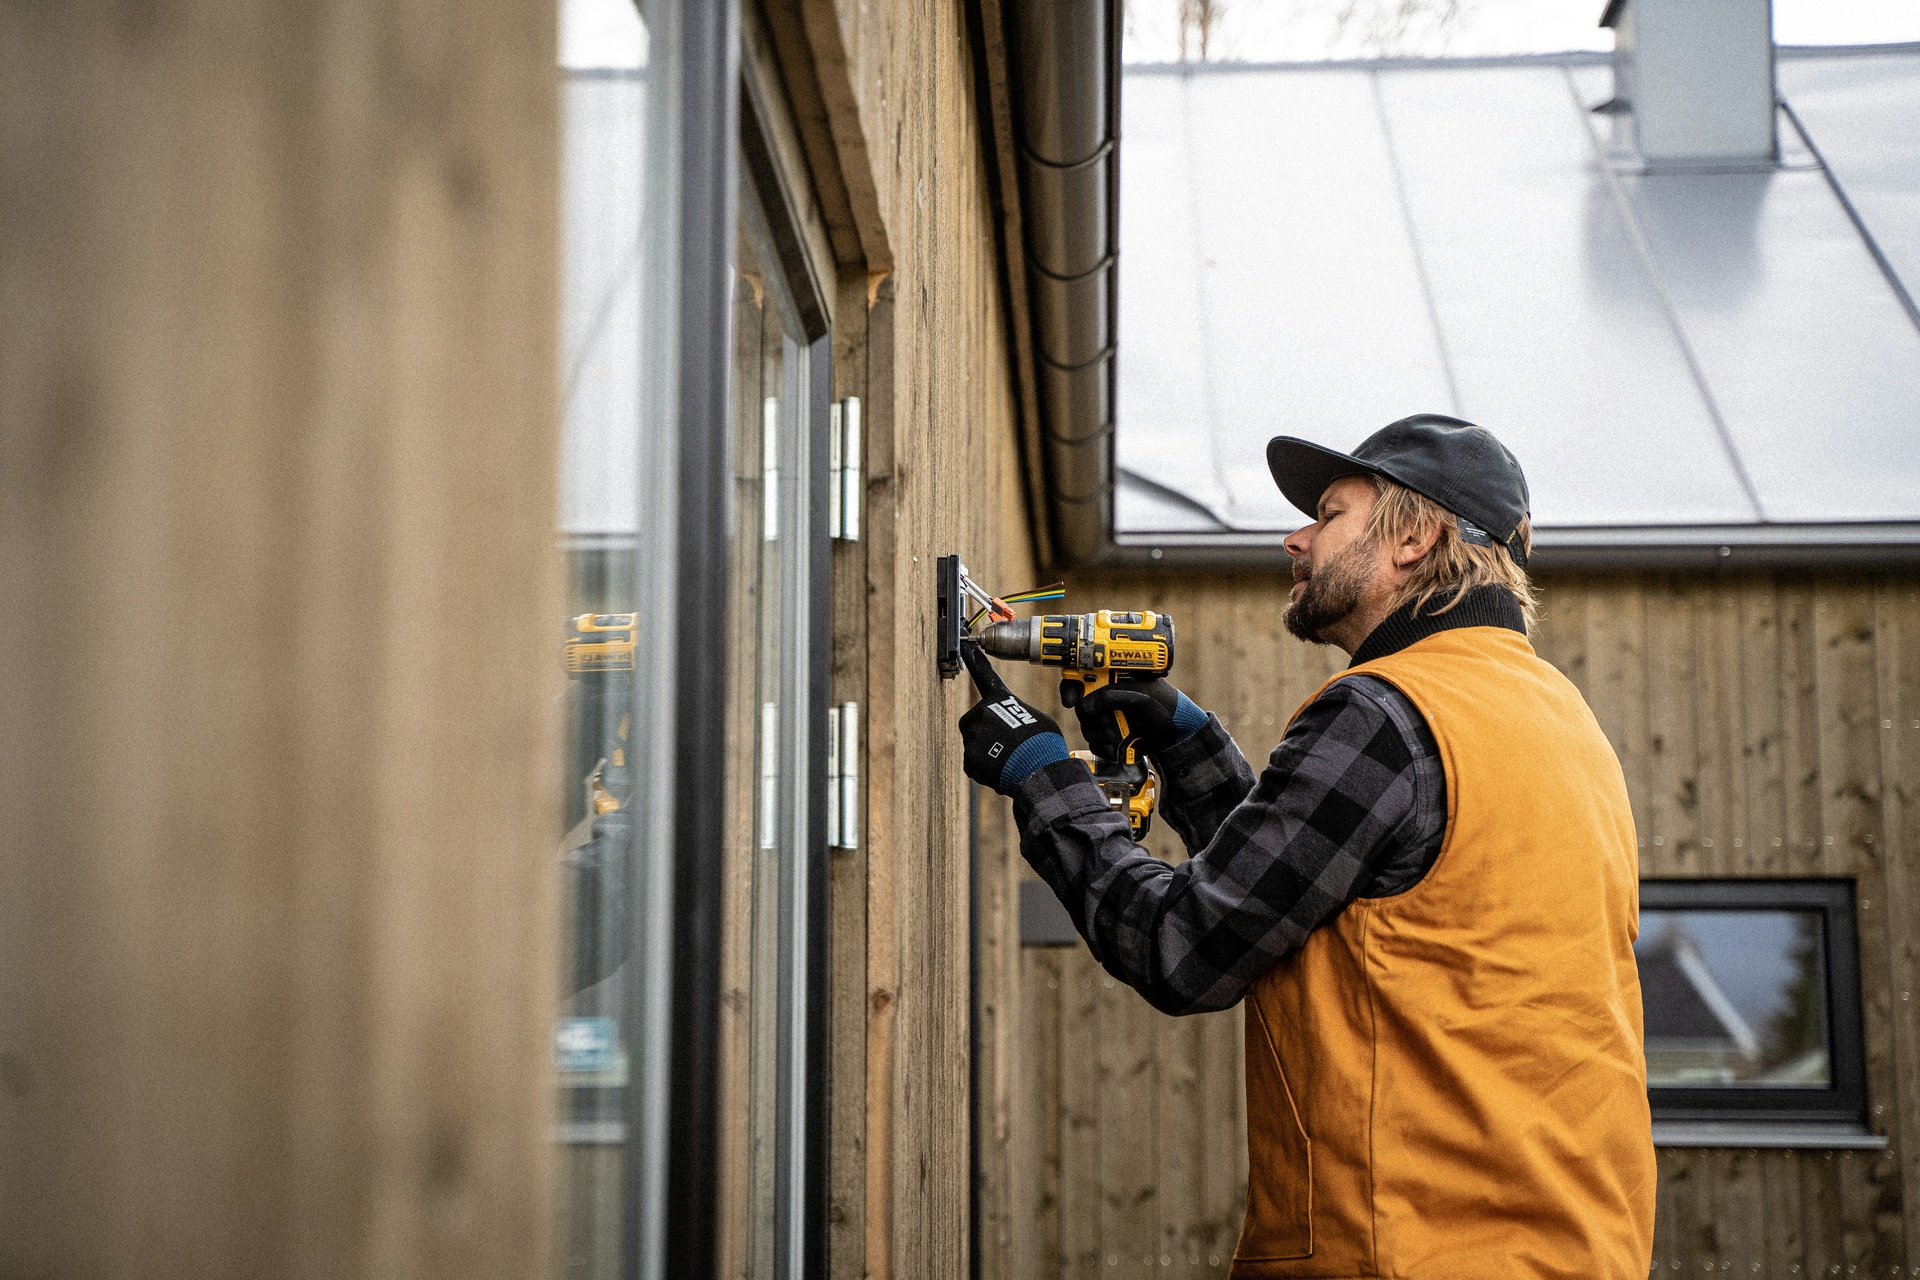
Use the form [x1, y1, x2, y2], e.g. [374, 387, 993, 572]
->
[641, 0, 739, 1280]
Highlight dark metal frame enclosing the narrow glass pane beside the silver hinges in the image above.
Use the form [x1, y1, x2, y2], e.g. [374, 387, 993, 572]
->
[637, 0, 831, 1280]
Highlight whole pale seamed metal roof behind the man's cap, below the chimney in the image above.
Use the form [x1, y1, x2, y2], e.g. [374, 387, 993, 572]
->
[1116, 46, 1920, 558]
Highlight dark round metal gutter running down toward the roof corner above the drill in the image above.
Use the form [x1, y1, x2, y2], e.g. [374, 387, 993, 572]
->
[1004, 0, 1121, 568]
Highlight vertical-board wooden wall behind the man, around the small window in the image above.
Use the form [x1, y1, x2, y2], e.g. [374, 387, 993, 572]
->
[983, 574, 1920, 1278]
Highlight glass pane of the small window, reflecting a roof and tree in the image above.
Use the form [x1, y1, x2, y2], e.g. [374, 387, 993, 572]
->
[1634, 910, 1832, 1088]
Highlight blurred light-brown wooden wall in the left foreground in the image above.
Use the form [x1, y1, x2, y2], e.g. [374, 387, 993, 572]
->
[0, 0, 563, 1280]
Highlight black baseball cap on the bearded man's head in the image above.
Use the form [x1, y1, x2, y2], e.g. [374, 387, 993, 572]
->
[1267, 413, 1530, 564]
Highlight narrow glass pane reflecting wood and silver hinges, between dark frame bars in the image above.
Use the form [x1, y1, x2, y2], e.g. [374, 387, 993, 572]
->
[722, 135, 828, 1278]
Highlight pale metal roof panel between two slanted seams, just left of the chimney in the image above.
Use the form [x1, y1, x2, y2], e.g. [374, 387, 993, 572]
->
[1382, 65, 1755, 526]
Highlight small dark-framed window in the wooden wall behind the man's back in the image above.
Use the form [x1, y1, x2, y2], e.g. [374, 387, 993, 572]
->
[1634, 881, 1866, 1125]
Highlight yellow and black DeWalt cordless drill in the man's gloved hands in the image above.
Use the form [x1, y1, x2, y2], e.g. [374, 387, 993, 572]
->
[973, 608, 1173, 841]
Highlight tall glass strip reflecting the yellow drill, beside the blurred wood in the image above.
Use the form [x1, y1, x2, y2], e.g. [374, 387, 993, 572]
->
[553, 0, 662, 1280]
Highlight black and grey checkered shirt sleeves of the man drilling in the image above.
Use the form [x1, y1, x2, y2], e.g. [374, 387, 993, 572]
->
[1014, 676, 1446, 1013]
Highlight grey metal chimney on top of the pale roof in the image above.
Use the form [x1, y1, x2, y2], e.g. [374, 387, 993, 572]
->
[1599, 0, 1778, 169]
